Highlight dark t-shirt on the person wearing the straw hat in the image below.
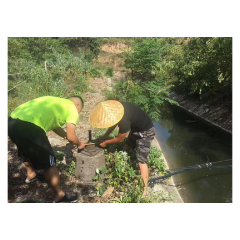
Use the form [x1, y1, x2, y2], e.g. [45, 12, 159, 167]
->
[117, 101, 153, 133]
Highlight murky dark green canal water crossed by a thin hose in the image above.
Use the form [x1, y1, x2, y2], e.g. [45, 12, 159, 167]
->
[154, 106, 233, 203]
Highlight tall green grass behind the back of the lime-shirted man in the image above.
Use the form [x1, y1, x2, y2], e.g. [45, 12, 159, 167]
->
[7, 39, 92, 116]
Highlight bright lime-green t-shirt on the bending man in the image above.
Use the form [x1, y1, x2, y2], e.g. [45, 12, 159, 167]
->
[11, 96, 78, 132]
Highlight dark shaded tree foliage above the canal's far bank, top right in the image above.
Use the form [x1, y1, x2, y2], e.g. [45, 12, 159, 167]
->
[163, 37, 233, 99]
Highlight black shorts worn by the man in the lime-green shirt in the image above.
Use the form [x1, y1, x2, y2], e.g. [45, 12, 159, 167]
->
[7, 118, 56, 169]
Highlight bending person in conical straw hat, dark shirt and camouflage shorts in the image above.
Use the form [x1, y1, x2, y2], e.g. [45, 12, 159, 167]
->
[89, 100, 155, 195]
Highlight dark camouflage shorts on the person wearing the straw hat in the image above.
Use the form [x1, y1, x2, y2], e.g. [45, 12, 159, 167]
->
[126, 127, 155, 163]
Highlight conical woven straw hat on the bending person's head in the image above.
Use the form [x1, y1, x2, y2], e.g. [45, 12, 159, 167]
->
[89, 100, 124, 128]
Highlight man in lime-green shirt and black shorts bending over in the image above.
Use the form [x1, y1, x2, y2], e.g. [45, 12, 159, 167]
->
[7, 96, 85, 203]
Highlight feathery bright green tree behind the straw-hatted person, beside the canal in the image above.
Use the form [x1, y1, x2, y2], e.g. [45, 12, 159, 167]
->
[102, 37, 177, 120]
